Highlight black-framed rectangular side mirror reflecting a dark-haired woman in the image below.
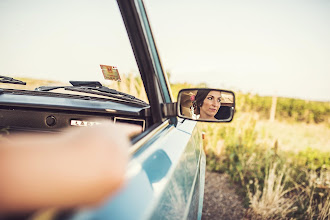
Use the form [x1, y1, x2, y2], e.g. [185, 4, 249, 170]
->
[177, 88, 235, 122]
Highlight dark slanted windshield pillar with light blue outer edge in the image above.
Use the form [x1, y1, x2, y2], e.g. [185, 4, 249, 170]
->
[117, 0, 172, 124]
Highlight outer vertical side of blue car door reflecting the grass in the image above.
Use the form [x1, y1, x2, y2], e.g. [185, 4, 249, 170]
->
[151, 121, 204, 219]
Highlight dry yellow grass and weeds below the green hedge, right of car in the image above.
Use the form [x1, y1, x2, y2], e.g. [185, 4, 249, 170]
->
[204, 113, 330, 219]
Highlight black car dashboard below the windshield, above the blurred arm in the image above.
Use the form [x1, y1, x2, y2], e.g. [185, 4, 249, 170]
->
[0, 89, 150, 133]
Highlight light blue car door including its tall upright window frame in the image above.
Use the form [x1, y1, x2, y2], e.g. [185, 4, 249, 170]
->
[66, 0, 205, 219]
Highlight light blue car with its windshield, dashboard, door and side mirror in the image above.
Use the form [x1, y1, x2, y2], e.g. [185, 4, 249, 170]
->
[0, 0, 235, 220]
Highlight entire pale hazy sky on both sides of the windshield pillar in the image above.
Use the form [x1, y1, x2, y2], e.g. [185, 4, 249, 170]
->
[0, 0, 330, 101]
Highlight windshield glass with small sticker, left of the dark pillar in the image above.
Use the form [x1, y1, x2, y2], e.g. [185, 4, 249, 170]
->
[0, 0, 147, 101]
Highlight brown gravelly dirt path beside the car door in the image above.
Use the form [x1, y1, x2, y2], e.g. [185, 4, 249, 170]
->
[202, 171, 245, 220]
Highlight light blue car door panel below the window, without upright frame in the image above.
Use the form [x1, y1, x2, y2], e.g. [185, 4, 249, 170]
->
[69, 121, 204, 219]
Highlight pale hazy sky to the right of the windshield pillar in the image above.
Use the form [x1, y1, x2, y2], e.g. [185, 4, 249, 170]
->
[147, 0, 330, 101]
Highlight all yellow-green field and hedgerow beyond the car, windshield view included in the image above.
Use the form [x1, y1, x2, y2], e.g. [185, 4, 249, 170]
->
[3, 75, 330, 219]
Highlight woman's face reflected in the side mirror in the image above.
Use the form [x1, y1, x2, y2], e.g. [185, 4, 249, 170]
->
[199, 91, 221, 120]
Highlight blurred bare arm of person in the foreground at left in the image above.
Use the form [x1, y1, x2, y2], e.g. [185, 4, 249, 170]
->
[0, 122, 138, 212]
